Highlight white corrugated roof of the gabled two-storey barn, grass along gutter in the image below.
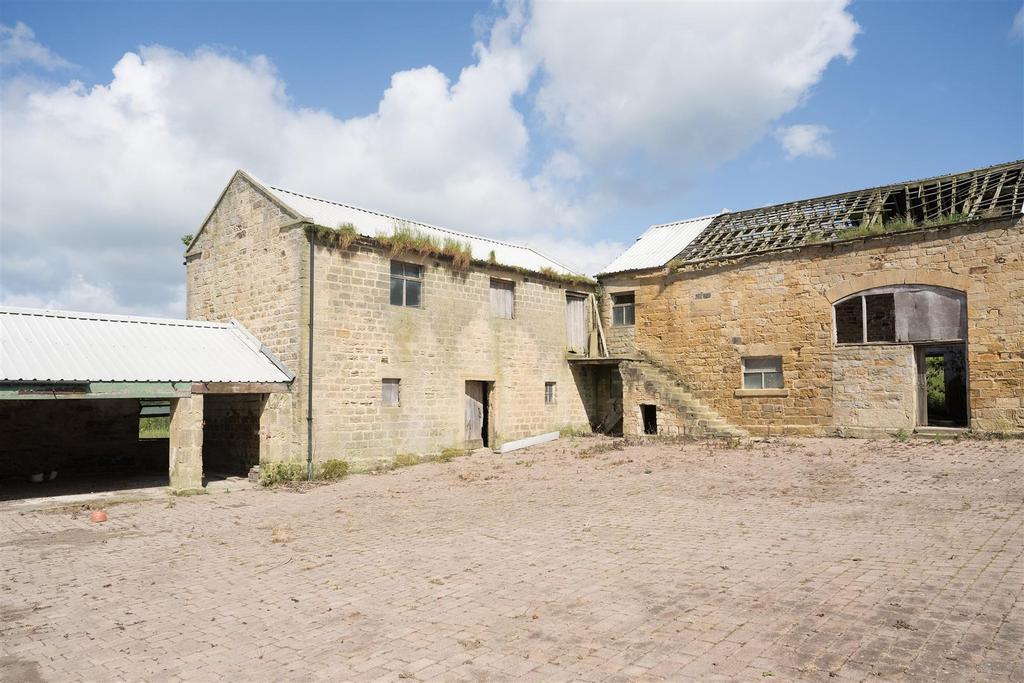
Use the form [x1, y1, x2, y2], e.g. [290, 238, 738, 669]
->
[247, 174, 579, 274]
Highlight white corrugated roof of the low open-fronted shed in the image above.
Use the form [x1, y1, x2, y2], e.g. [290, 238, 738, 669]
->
[0, 307, 292, 383]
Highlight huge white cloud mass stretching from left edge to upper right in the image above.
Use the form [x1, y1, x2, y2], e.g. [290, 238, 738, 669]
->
[0, 2, 857, 314]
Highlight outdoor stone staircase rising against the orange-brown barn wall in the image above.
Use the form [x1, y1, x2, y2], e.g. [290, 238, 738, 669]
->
[622, 357, 746, 438]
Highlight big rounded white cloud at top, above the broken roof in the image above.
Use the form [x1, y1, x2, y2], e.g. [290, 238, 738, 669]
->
[523, 1, 859, 184]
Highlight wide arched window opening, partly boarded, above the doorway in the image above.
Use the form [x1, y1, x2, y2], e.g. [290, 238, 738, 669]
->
[833, 285, 967, 344]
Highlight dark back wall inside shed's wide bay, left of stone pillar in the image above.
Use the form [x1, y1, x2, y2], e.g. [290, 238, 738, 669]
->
[0, 398, 167, 478]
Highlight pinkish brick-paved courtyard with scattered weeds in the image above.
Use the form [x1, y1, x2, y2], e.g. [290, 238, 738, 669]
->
[0, 438, 1024, 681]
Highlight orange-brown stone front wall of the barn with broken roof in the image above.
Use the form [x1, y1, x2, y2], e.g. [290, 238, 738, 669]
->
[605, 220, 1024, 434]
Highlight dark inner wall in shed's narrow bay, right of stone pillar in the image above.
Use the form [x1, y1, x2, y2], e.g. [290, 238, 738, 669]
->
[203, 394, 266, 476]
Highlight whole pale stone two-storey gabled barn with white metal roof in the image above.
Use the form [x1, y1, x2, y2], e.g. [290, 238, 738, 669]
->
[185, 171, 597, 470]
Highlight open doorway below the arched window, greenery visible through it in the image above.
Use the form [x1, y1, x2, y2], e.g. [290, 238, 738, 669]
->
[916, 344, 968, 427]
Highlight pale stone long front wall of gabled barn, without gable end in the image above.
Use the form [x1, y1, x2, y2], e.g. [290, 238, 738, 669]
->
[313, 243, 588, 468]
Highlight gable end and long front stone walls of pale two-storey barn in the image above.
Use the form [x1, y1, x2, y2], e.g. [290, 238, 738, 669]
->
[186, 177, 589, 469]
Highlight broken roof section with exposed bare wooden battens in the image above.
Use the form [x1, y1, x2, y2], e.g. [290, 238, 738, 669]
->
[676, 161, 1024, 264]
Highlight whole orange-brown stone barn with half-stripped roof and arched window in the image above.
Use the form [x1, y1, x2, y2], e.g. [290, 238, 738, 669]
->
[598, 162, 1024, 435]
